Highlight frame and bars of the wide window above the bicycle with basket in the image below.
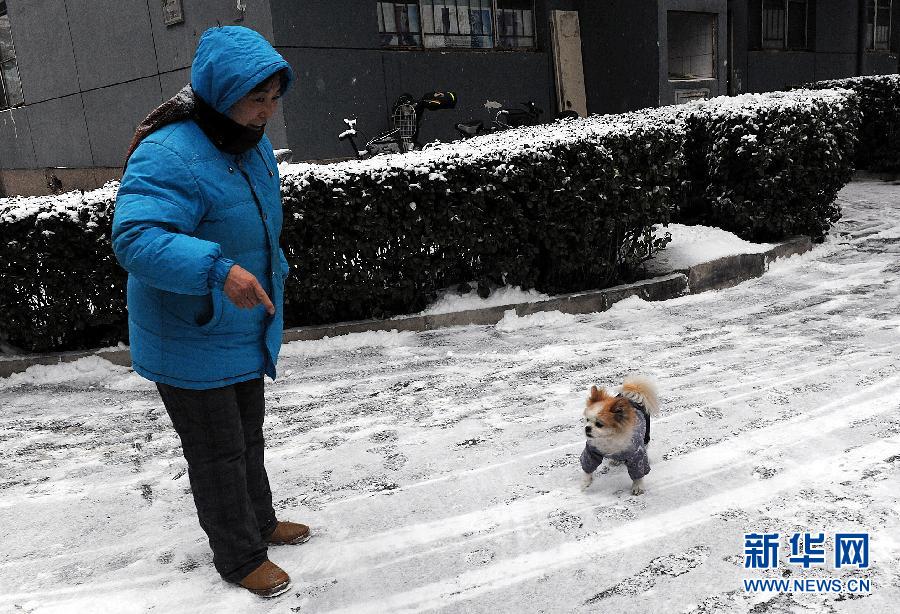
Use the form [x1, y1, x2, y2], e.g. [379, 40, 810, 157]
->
[375, 0, 538, 52]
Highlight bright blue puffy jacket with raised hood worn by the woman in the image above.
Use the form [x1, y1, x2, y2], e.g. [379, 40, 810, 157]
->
[112, 26, 294, 389]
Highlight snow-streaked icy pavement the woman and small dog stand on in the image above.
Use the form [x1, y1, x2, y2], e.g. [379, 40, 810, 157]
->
[0, 182, 900, 614]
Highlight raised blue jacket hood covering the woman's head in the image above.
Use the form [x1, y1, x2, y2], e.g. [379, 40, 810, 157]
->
[191, 26, 294, 115]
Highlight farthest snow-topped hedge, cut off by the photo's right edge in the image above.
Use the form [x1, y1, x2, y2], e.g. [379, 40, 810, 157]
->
[804, 75, 900, 173]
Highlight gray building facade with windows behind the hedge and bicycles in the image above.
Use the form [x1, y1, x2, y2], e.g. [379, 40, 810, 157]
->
[0, 0, 900, 195]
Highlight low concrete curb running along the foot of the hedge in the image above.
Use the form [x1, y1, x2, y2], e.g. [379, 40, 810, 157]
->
[0, 237, 812, 377]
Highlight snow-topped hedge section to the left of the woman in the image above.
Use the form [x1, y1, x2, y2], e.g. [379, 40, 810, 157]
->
[0, 183, 127, 352]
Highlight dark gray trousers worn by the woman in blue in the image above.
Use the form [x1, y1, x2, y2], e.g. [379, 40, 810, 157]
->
[156, 378, 276, 582]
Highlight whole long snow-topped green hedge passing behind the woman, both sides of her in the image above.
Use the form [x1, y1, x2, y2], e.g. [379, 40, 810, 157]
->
[0, 90, 858, 351]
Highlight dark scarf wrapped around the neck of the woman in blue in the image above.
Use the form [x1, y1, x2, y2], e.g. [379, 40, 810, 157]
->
[125, 85, 265, 165]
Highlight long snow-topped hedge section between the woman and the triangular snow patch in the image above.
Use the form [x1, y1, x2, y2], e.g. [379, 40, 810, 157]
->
[282, 113, 682, 330]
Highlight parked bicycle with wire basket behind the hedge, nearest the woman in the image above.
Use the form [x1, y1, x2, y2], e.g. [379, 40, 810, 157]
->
[338, 92, 456, 160]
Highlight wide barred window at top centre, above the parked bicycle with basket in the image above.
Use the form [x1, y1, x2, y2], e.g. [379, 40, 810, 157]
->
[376, 0, 535, 49]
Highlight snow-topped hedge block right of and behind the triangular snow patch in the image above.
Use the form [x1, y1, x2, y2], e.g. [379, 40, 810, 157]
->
[679, 90, 859, 241]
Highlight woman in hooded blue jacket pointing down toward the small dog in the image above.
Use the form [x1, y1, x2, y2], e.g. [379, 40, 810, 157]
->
[112, 26, 309, 596]
